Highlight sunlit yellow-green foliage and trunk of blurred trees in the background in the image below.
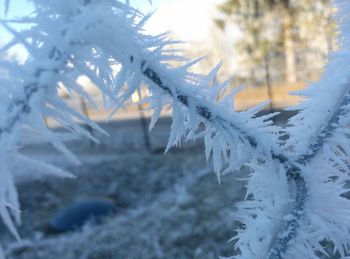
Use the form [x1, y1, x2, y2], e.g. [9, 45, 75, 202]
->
[216, 0, 335, 83]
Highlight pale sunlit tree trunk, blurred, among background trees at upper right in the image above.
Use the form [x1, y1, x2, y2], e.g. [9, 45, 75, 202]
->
[283, 14, 297, 83]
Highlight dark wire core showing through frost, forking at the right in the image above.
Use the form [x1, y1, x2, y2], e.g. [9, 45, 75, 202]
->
[137, 48, 349, 259]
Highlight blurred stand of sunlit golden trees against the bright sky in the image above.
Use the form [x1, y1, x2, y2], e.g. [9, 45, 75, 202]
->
[215, 0, 336, 86]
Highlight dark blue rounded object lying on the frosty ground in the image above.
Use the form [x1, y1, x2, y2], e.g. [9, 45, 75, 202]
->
[50, 198, 116, 232]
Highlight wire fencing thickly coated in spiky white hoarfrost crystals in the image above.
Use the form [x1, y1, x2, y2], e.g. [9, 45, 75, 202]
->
[0, 0, 350, 259]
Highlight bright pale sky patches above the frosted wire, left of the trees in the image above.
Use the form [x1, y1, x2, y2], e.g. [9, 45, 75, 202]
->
[0, 0, 230, 64]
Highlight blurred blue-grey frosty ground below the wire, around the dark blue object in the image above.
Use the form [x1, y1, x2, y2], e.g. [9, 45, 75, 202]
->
[1, 119, 245, 259]
